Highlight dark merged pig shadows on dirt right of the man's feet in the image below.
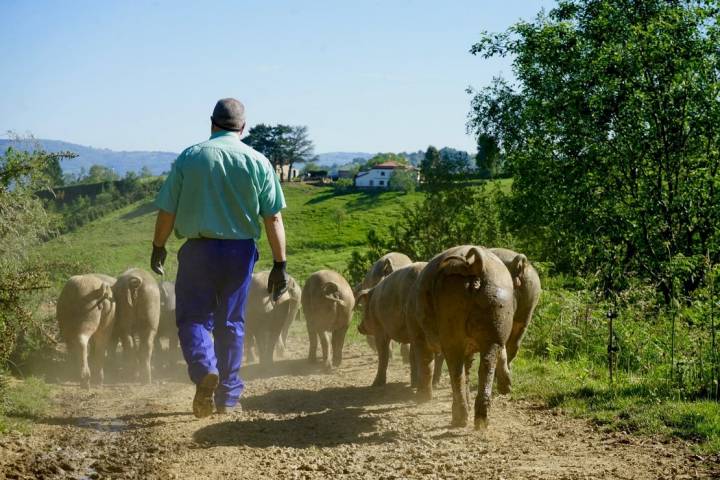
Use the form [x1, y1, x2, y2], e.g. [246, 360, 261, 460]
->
[193, 383, 413, 448]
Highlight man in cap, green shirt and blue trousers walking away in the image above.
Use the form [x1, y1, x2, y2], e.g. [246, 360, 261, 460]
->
[150, 98, 288, 418]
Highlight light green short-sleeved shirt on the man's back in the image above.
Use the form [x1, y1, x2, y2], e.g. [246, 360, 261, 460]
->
[155, 131, 285, 240]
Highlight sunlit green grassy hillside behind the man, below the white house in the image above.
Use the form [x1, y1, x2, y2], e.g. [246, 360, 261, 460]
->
[33, 184, 422, 283]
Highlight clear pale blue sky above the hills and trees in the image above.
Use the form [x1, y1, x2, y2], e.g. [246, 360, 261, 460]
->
[0, 0, 555, 152]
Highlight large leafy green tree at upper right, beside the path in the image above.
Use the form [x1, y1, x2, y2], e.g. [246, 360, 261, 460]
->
[469, 0, 720, 299]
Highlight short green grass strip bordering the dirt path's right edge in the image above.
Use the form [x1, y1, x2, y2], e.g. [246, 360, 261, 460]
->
[512, 356, 720, 454]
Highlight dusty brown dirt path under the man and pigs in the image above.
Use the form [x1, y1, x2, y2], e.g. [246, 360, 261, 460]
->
[0, 339, 720, 480]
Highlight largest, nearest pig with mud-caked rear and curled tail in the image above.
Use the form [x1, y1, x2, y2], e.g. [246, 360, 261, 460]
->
[408, 245, 514, 429]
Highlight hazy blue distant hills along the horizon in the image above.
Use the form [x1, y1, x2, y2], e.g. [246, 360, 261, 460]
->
[0, 138, 374, 176]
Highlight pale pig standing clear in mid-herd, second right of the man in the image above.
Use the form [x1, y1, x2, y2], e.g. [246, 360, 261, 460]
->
[301, 270, 355, 368]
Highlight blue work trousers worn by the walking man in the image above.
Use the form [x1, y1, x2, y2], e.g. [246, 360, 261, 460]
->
[175, 239, 258, 407]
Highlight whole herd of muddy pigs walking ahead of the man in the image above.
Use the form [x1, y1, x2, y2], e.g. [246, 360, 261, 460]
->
[57, 245, 541, 428]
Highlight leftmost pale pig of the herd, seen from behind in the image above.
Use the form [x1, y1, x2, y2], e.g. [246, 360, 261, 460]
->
[57, 274, 115, 388]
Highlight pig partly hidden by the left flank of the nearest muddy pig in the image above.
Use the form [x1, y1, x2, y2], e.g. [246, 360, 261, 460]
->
[358, 262, 427, 386]
